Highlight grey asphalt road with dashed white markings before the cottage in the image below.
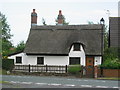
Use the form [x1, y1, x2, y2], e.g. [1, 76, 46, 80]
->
[0, 75, 120, 88]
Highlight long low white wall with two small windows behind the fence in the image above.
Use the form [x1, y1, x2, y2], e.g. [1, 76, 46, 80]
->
[8, 53, 69, 65]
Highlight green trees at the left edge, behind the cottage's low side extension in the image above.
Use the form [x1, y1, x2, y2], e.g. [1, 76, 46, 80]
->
[0, 12, 25, 59]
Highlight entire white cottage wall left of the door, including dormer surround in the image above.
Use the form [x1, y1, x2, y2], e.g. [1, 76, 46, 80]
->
[8, 46, 85, 66]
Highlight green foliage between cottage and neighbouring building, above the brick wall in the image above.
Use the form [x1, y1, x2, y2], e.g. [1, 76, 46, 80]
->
[100, 22, 120, 69]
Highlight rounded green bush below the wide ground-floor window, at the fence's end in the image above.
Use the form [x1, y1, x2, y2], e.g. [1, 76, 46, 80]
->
[68, 65, 81, 75]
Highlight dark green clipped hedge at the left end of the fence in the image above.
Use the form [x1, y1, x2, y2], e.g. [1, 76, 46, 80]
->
[2, 59, 14, 71]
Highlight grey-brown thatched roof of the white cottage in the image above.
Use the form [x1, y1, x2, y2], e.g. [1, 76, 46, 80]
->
[24, 24, 102, 55]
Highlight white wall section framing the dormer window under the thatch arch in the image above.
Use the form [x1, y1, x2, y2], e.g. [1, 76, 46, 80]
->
[69, 45, 86, 66]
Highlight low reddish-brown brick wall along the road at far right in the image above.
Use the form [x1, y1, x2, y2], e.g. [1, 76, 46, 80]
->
[103, 69, 120, 77]
